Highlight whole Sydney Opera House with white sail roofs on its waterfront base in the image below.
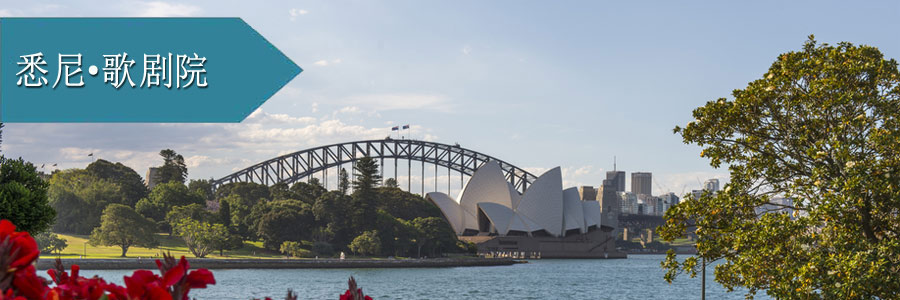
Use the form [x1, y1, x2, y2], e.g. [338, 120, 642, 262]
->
[426, 161, 625, 258]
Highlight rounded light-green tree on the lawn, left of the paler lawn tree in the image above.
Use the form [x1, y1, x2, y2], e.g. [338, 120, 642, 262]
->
[89, 204, 158, 257]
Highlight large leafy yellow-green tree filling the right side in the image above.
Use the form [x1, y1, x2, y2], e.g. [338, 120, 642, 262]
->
[660, 36, 900, 299]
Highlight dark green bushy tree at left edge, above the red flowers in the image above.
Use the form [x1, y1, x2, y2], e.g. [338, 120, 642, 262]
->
[0, 156, 56, 234]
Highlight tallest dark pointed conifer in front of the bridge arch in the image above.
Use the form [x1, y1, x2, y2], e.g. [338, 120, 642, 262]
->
[348, 156, 381, 230]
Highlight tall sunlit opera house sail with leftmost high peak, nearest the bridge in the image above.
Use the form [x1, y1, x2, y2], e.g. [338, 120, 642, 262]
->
[457, 161, 513, 228]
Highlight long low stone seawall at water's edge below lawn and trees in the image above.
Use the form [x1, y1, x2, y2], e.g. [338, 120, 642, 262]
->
[35, 257, 525, 270]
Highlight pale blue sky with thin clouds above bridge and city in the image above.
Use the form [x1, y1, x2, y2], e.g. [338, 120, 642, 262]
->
[0, 0, 900, 194]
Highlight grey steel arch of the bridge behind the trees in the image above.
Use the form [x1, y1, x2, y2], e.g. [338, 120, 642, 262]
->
[212, 139, 537, 192]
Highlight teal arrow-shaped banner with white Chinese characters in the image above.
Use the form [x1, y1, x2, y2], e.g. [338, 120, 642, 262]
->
[0, 18, 302, 123]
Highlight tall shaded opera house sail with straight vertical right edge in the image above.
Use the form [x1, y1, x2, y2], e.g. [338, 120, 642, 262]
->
[516, 167, 563, 236]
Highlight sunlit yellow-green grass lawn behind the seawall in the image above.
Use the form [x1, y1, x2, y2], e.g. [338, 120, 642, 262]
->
[41, 234, 284, 258]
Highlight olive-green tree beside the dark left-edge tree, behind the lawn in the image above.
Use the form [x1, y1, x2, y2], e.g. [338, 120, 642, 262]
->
[49, 169, 130, 234]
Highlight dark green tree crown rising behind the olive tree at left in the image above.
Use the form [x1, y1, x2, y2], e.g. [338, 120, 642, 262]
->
[85, 159, 149, 206]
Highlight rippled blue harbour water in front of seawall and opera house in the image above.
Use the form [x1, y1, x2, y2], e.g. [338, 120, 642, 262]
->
[82, 255, 769, 299]
